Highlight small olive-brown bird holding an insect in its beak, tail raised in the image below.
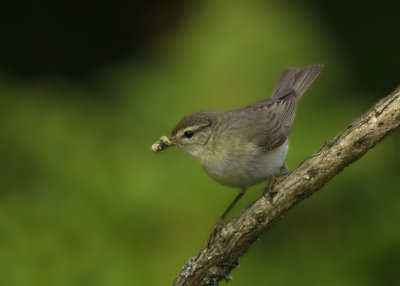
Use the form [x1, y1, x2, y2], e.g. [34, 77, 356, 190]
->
[152, 64, 323, 233]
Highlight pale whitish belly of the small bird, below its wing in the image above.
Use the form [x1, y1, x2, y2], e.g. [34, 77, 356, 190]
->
[202, 141, 288, 188]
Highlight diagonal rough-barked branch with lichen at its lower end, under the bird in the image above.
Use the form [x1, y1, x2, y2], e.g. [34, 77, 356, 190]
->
[173, 87, 400, 286]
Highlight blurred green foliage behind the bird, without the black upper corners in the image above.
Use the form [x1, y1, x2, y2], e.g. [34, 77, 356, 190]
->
[0, 1, 400, 285]
